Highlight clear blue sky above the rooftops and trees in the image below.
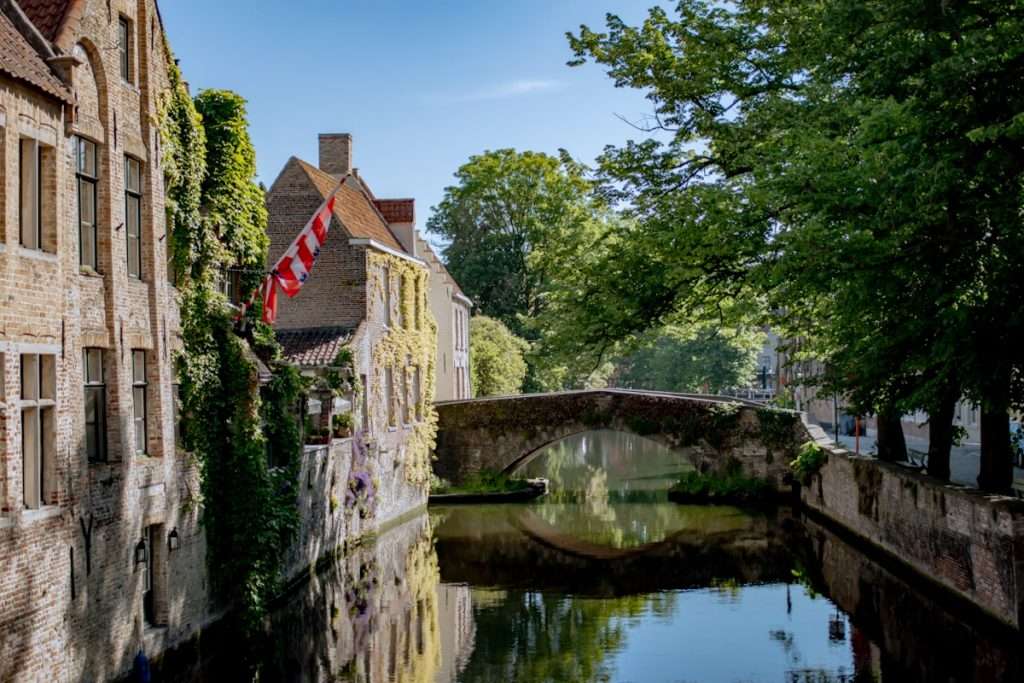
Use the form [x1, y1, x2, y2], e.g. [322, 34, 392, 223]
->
[161, 0, 656, 228]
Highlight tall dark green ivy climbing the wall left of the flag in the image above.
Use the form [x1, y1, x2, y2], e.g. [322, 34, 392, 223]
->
[161, 50, 303, 630]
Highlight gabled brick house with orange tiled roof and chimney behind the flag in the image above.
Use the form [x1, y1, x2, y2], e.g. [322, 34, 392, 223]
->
[266, 134, 468, 509]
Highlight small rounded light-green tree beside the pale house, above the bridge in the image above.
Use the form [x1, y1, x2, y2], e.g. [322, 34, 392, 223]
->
[469, 315, 529, 396]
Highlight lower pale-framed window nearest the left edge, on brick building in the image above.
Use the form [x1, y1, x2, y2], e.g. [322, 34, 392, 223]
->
[22, 353, 56, 510]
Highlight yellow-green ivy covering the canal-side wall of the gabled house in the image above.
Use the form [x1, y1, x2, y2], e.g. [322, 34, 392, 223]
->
[367, 252, 437, 489]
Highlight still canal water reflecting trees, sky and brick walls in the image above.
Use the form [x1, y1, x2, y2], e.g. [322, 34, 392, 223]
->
[203, 431, 1024, 683]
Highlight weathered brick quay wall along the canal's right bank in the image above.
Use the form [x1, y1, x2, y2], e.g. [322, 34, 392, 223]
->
[800, 426, 1024, 629]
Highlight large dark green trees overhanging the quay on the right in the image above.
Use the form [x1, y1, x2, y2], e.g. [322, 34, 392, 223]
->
[569, 0, 1024, 490]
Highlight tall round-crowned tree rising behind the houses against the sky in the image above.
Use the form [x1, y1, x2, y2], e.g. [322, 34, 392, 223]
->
[427, 150, 596, 336]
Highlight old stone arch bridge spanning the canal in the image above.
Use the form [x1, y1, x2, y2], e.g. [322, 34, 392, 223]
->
[434, 389, 810, 488]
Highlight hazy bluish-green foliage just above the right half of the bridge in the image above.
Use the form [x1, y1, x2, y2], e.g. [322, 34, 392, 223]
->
[615, 327, 764, 393]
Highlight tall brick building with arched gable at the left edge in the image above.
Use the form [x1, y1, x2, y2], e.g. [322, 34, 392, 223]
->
[0, 0, 221, 681]
